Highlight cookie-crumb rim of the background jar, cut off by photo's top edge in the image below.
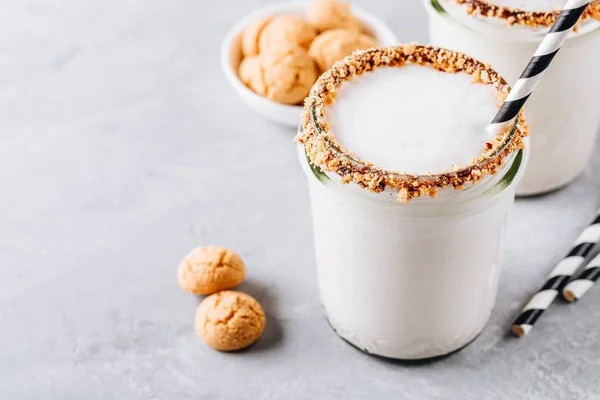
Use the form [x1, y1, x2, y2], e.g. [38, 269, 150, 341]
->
[438, 0, 600, 28]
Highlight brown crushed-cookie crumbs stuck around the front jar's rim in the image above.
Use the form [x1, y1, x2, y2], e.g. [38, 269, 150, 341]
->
[297, 44, 528, 203]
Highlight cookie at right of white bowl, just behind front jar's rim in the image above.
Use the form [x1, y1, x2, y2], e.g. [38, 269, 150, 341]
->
[308, 29, 377, 72]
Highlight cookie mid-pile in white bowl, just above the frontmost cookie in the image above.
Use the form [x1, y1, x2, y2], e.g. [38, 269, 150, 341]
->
[258, 15, 317, 53]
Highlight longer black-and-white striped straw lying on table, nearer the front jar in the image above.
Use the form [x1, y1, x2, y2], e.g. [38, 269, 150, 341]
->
[512, 210, 600, 336]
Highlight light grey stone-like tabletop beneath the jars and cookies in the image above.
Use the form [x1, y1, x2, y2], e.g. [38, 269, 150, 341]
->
[0, 0, 600, 400]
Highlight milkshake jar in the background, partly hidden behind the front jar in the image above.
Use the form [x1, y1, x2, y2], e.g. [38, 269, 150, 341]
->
[423, 0, 600, 195]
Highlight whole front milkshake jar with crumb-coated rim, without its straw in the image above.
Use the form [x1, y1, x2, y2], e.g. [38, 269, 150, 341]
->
[297, 45, 527, 359]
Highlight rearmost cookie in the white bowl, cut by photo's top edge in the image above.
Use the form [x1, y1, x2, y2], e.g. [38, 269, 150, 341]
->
[307, 0, 363, 32]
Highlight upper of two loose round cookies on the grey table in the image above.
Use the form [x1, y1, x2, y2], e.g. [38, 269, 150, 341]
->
[177, 246, 246, 294]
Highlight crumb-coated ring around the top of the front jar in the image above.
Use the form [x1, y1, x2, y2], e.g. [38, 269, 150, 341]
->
[297, 44, 528, 203]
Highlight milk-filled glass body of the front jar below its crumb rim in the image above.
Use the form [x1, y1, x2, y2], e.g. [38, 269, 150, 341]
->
[298, 130, 528, 360]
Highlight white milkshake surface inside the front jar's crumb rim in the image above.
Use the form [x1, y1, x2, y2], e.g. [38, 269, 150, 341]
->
[328, 65, 500, 174]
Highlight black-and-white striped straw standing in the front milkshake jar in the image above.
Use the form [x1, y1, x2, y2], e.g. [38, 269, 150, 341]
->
[488, 0, 590, 136]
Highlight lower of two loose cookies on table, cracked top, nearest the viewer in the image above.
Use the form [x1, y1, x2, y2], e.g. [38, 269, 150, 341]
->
[196, 290, 265, 351]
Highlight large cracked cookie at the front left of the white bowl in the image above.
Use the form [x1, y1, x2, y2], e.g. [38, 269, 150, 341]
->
[239, 46, 318, 104]
